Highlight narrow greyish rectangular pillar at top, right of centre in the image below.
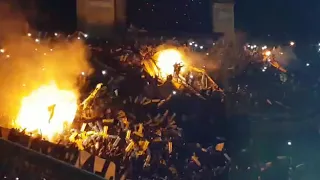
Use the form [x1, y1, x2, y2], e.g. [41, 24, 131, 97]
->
[213, 3, 234, 34]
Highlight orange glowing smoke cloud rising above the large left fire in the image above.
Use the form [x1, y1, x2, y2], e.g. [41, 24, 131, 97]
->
[0, 3, 91, 121]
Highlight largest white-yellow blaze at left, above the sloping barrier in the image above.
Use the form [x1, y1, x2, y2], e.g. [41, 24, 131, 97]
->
[15, 83, 77, 140]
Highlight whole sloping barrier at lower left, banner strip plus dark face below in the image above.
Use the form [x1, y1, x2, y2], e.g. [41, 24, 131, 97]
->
[0, 127, 121, 180]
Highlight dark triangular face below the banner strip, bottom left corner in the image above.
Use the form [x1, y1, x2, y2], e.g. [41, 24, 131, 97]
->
[0, 139, 103, 180]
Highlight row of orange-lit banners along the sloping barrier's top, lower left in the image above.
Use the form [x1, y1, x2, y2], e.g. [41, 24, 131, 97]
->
[0, 127, 120, 179]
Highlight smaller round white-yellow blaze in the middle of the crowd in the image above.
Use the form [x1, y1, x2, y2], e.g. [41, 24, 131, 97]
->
[157, 49, 184, 78]
